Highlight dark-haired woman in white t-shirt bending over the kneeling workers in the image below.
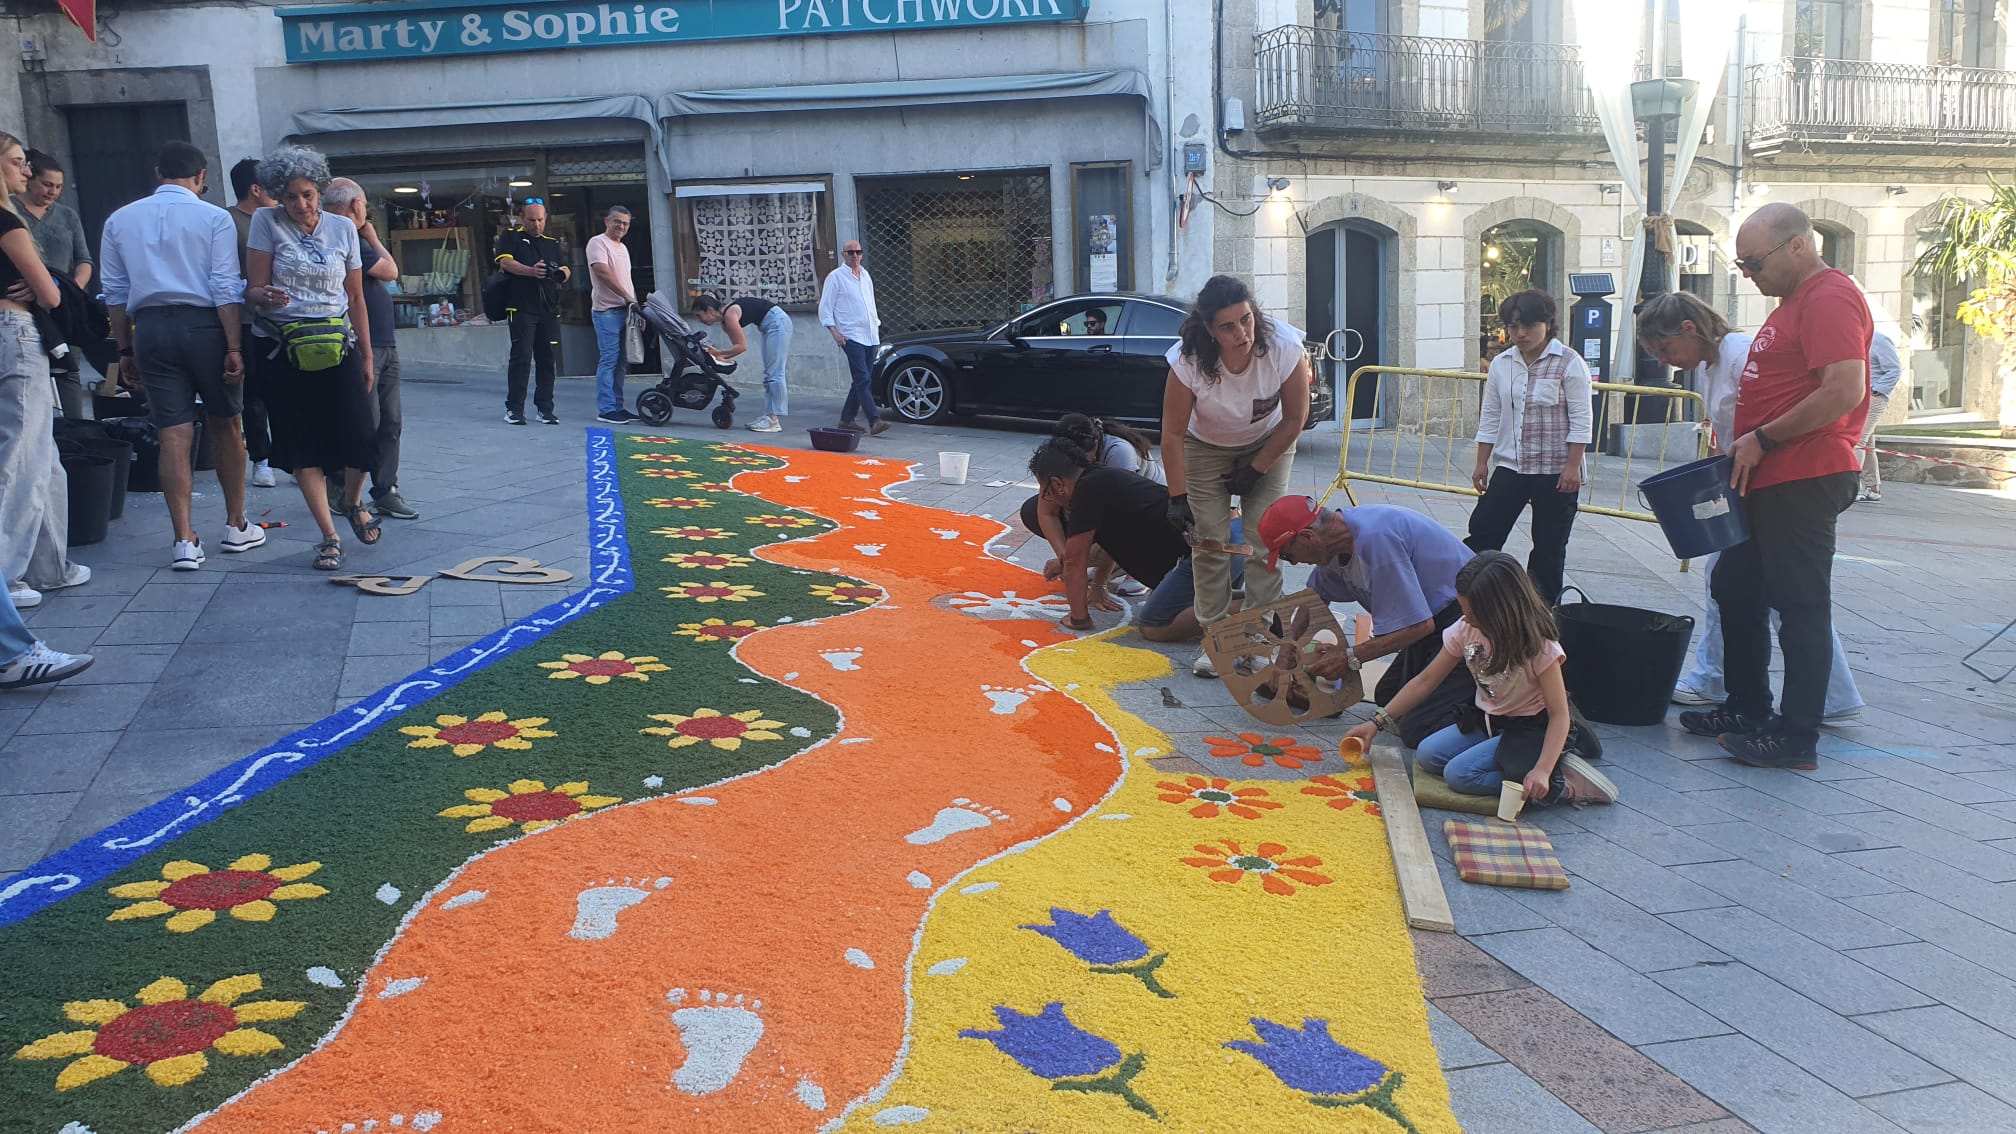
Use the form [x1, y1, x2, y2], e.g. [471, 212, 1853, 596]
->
[1161, 276, 1310, 678]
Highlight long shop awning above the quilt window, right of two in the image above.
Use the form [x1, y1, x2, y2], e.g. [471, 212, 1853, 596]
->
[657, 71, 1149, 119]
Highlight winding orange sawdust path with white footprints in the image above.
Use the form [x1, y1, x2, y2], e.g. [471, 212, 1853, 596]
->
[202, 450, 1121, 1134]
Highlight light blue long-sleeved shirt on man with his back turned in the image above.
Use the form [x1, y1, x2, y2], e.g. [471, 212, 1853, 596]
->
[99, 186, 244, 313]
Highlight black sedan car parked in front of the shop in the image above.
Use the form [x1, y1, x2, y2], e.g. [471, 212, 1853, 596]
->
[873, 293, 1329, 426]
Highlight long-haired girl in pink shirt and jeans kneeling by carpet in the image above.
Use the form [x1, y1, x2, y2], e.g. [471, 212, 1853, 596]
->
[1351, 551, 1617, 805]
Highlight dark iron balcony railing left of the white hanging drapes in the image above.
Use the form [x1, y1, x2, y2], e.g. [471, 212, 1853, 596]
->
[1254, 26, 1601, 137]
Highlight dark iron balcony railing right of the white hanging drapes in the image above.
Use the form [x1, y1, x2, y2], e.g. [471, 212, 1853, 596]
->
[1748, 59, 2016, 149]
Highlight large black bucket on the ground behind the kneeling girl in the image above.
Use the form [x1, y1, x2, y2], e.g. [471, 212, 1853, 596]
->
[1554, 587, 1693, 724]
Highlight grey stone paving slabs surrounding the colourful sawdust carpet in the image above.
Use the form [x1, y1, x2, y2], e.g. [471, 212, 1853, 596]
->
[0, 371, 2016, 1134]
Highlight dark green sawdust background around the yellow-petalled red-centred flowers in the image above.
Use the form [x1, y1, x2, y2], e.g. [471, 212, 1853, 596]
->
[0, 438, 863, 1134]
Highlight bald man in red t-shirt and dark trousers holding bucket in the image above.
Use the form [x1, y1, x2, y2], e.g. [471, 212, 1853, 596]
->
[1679, 204, 1873, 771]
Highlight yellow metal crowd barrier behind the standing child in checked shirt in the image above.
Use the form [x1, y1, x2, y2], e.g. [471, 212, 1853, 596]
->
[1322, 365, 1708, 523]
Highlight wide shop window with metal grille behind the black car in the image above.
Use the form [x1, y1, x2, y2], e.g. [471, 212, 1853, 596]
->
[855, 172, 1056, 333]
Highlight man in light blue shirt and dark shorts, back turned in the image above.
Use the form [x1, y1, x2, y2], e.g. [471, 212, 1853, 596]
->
[99, 141, 266, 571]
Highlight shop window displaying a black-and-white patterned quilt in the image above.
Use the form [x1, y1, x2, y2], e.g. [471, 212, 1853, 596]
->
[673, 180, 837, 311]
